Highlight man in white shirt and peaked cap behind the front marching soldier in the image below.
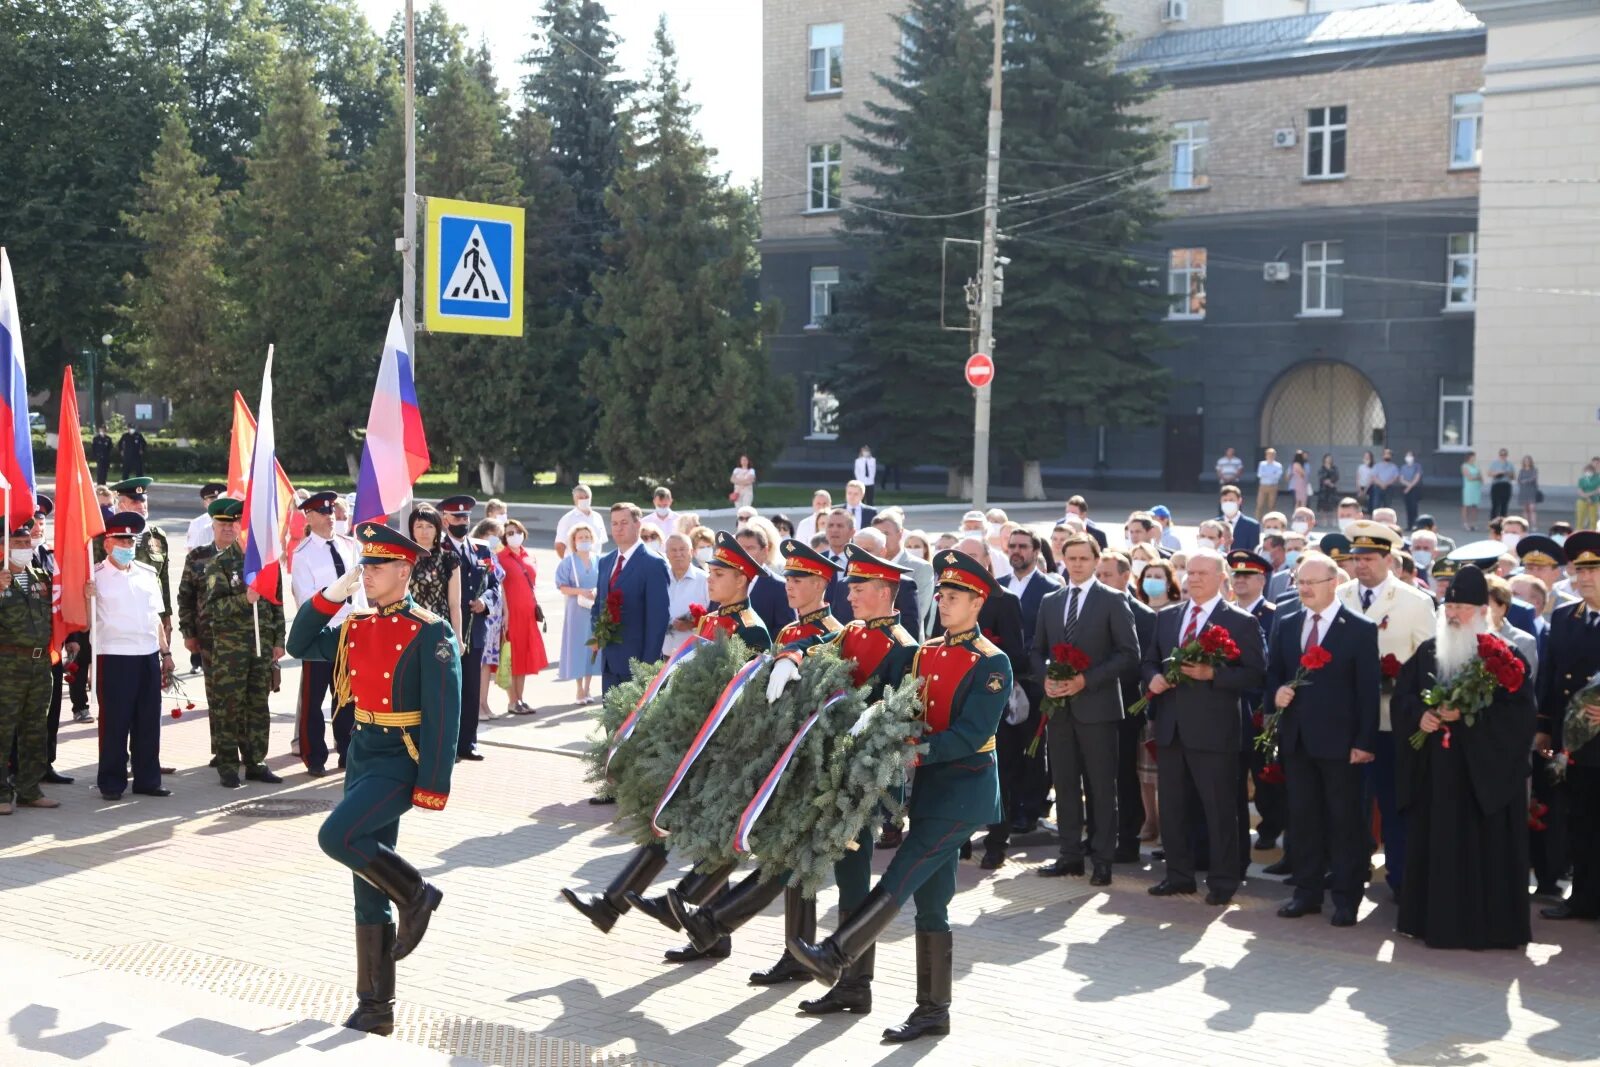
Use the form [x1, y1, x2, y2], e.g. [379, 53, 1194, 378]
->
[291, 493, 366, 777]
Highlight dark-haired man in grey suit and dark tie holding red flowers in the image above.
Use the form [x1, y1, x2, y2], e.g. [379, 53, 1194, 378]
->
[1030, 534, 1139, 886]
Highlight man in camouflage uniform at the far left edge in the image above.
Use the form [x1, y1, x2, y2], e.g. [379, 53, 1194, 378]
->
[0, 517, 61, 814]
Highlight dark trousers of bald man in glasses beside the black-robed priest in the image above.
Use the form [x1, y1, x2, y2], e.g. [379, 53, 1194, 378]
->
[1283, 749, 1371, 907]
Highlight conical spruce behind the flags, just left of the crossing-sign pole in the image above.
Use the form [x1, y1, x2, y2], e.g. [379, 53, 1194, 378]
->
[230, 53, 369, 470]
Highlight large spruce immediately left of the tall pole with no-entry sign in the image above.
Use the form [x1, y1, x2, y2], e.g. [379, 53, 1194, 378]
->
[829, 0, 990, 483]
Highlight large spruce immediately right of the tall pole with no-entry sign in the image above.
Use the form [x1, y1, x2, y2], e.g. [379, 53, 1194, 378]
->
[992, 0, 1166, 499]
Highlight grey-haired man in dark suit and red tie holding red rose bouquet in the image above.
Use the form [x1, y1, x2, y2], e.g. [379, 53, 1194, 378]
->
[1141, 550, 1266, 905]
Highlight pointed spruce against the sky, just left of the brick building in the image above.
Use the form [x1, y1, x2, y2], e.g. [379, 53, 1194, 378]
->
[584, 22, 781, 493]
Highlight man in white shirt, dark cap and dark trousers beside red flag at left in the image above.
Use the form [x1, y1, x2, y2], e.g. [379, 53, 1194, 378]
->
[85, 512, 173, 800]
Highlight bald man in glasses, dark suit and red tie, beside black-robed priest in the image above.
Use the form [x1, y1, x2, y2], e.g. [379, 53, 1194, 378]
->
[1266, 552, 1382, 926]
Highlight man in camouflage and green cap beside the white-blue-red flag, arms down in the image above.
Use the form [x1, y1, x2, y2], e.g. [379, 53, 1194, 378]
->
[205, 501, 283, 789]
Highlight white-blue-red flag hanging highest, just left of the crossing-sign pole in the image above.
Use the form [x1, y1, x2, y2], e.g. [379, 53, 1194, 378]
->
[354, 301, 429, 523]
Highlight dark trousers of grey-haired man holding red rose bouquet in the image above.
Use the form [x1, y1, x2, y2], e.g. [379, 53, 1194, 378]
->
[1155, 742, 1240, 893]
